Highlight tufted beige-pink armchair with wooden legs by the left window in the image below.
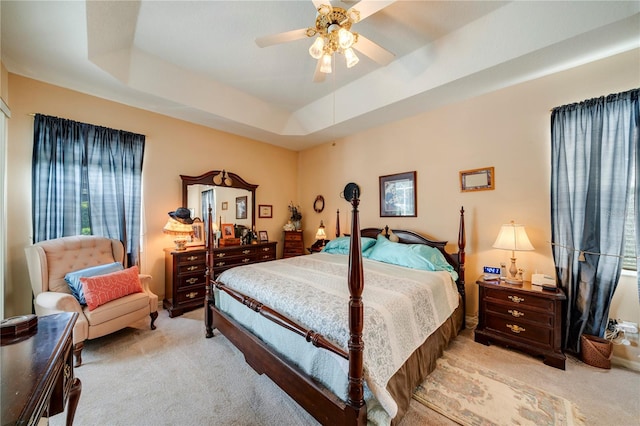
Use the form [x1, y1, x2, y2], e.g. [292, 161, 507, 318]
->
[25, 236, 158, 367]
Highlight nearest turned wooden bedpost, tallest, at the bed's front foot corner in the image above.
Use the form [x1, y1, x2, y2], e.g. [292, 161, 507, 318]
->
[348, 194, 364, 414]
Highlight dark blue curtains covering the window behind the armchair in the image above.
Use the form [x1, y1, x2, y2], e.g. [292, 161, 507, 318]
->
[32, 114, 145, 265]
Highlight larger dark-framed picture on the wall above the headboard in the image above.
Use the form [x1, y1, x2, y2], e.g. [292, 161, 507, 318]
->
[379, 171, 418, 217]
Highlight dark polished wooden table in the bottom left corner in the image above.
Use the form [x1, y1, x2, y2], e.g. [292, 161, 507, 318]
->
[1, 312, 82, 425]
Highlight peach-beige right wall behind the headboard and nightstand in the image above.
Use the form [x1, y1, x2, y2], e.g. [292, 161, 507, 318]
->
[299, 50, 640, 362]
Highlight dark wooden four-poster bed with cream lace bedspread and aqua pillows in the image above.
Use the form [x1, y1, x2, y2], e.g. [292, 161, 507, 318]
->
[205, 197, 465, 425]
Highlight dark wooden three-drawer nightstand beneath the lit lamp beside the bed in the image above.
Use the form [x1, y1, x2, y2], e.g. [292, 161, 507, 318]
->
[475, 278, 566, 370]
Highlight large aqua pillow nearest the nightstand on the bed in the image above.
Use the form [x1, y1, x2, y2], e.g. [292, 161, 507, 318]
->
[362, 235, 458, 280]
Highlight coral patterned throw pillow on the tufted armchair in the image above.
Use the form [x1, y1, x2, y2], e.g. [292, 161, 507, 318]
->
[80, 266, 142, 311]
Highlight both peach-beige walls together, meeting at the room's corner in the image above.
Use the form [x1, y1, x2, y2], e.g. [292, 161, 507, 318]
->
[5, 50, 640, 359]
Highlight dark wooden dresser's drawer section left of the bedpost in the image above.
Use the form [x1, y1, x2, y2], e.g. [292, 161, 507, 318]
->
[162, 247, 207, 318]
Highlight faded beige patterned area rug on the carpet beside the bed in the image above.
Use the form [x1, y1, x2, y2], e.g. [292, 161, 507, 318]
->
[413, 353, 584, 426]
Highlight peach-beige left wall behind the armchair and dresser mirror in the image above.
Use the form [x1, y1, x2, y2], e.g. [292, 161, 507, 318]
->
[5, 74, 298, 316]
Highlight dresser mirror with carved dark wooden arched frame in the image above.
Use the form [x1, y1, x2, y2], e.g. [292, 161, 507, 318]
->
[180, 170, 258, 236]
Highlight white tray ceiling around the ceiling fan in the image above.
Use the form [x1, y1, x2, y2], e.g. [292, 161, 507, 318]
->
[0, 0, 640, 150]
